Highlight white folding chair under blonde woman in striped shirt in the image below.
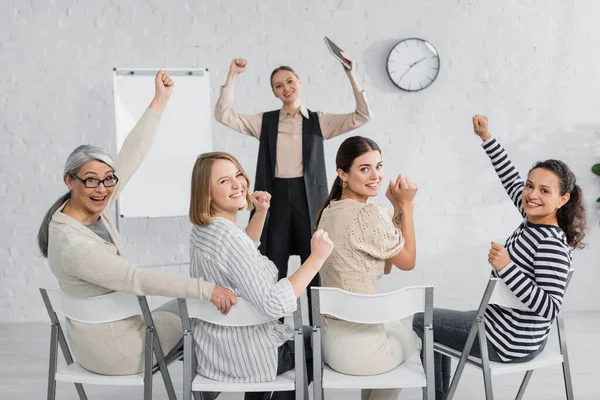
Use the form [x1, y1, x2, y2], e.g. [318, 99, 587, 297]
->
[179, 298, 308, 400]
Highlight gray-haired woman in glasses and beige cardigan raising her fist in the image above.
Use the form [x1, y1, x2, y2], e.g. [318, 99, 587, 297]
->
[38, 70, 236, 375]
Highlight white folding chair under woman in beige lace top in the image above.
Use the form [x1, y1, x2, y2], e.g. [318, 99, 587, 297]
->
[311, 286, 435, 400]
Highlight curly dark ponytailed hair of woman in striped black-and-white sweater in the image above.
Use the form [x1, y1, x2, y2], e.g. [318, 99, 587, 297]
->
[529, 160, 587, 249]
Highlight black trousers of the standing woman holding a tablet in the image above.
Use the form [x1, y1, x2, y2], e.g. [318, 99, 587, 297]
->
[266, 178, 321, 326]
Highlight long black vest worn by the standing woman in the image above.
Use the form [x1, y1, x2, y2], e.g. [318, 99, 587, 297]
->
[254, 110, 329, 254]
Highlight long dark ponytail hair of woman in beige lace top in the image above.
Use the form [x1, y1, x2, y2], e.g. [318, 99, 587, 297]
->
[315, 136, 381, 227]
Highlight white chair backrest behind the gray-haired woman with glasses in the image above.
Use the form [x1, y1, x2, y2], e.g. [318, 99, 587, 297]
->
[40, 289, 142, 324]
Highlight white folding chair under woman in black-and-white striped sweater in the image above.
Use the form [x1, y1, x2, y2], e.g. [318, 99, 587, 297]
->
[434, 269, 574, 400]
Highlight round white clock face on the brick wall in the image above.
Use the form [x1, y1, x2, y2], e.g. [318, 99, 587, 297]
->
[387, 38, 440, 92]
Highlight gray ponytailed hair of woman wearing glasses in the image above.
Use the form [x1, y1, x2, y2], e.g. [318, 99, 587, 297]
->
[38, 144, 115, 258]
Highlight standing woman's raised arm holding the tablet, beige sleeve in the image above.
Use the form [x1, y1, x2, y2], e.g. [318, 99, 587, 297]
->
[318, 53, 373, 139]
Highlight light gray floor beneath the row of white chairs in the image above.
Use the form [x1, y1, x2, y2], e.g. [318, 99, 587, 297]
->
[0, 313, 600, 400]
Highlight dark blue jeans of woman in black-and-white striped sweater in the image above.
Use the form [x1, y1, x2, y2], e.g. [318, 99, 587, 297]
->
[413, 308, 545, 400]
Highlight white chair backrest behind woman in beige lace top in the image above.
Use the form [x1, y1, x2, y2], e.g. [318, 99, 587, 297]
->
[311, 286, 433, 324]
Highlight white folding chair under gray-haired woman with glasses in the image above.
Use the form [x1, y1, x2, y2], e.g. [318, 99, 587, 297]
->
[40, 288, 181, 400]
